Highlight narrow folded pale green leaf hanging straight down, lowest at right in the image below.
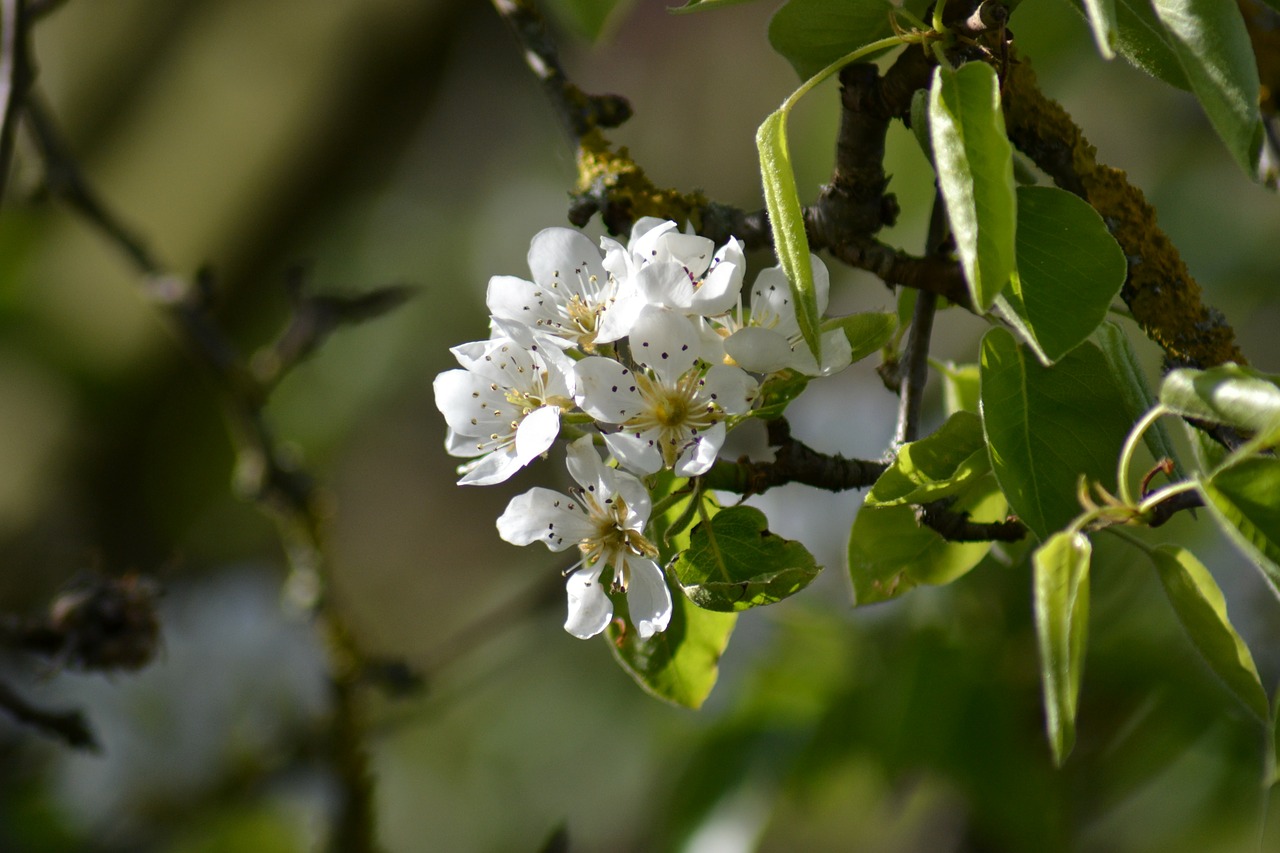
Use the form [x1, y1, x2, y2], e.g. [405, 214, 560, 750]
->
[1032, 530, 1093, 766]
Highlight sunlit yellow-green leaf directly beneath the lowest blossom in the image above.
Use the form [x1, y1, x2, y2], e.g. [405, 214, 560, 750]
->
[605, 589, 737, 708]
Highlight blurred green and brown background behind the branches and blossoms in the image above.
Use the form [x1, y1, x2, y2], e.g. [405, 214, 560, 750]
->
[0, 0, 1280, 853]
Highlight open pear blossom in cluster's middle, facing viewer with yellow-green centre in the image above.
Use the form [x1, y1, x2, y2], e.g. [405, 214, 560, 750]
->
[575, 305, 758, 476]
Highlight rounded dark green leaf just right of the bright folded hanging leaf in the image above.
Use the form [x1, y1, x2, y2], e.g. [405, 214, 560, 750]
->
[1005, 187, 1128, 364]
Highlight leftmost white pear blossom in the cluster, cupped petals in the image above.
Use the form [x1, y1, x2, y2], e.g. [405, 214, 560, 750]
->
[433, 323, 575, 485]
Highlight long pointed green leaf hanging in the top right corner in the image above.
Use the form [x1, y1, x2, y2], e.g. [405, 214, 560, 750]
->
[1152, 0, 1263, 179]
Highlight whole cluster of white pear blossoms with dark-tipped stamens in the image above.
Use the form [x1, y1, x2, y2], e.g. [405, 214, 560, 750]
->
[435, 218, 850, 638]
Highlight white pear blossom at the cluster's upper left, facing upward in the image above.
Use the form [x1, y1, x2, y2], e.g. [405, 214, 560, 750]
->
[485, 228, 644, 352]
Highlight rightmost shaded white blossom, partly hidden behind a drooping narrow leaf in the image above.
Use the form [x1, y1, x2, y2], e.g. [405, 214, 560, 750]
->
[722, 255, 852, 377]
